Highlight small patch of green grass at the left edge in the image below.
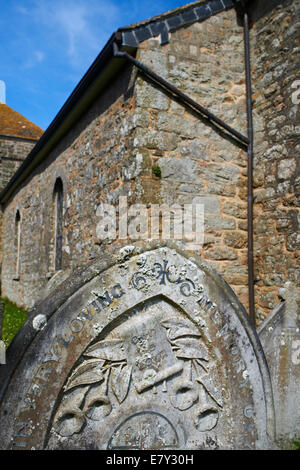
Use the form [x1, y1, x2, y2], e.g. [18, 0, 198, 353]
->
[0, 297, 27, 347]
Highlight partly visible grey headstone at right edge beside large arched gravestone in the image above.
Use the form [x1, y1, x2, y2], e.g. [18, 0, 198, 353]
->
[258, 282, 300, 449]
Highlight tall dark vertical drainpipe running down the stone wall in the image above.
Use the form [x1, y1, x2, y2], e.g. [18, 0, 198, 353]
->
[243, 7, 255, 326]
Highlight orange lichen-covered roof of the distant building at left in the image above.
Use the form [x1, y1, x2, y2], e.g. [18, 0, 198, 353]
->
[0, 103, 44, 140]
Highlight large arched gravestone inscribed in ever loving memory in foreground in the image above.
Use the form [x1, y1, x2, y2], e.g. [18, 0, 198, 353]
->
[0, 243, 274, 450]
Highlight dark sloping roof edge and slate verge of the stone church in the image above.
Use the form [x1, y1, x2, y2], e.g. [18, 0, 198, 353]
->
[0, 0, 236, 204]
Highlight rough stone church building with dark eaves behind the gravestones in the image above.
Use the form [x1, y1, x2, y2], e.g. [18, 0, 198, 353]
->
[1, 0, 300, 321]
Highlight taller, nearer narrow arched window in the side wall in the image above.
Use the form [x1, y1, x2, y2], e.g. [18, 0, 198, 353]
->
[53, 178, 64, 271]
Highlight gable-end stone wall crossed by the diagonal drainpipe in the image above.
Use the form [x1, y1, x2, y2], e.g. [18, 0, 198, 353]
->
[135, 10, 248, 307]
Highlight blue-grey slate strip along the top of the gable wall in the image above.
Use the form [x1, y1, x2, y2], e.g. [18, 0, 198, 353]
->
[118, 0, 236, 47]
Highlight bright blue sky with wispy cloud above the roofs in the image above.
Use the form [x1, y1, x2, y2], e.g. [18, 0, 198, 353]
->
[0, 0, 189, 129]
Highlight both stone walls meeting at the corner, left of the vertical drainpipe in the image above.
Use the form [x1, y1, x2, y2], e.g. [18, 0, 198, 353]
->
[2, 6, 251, 307]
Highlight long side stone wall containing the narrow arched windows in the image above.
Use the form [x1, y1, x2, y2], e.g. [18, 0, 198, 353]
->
[2, 70, 137, 308]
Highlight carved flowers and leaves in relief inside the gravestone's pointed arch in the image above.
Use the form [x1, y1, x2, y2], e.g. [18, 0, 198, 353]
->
[54, 314, 222, 436]
